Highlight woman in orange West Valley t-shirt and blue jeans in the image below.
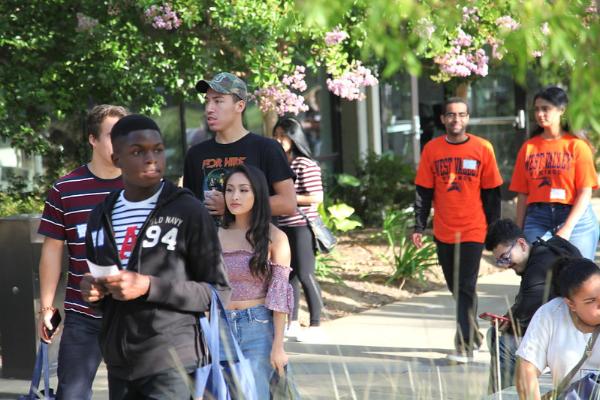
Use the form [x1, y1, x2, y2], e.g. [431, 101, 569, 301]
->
[510, 86, 599, 260]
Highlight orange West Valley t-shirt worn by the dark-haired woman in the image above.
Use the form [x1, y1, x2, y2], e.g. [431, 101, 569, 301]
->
[509, 134, 598, 204]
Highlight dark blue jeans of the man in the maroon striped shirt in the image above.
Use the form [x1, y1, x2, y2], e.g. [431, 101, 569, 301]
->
[56, 311, 102, 400]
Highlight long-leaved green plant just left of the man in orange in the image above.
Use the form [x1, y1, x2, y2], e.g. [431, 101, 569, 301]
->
[380, 208, 437, 288]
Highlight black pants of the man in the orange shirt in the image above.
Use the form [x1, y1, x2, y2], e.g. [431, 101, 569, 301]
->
[435, 239, 483, 354]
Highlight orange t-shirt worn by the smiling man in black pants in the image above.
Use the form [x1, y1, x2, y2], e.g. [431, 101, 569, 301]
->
[415, 134, 502, 243]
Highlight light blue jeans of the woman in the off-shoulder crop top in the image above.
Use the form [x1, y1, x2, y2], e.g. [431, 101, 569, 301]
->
[220, 306, 275, 399]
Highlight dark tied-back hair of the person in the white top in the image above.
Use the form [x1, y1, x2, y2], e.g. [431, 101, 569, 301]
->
[552, 257, 600, 299]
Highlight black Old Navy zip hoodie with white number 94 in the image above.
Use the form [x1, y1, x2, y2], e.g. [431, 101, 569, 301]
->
[86, 182, 231, 380]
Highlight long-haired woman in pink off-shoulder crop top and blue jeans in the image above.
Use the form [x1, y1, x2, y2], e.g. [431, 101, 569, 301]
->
[219, 165, 293, 399]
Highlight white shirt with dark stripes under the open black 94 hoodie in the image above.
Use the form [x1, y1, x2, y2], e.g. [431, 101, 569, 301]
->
[111, 186, 162, 269]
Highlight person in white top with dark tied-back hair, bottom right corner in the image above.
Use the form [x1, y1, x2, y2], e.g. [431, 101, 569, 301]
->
[516, 258, 600, 400]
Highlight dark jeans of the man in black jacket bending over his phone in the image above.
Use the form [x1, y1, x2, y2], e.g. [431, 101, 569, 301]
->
[487, 327, 519, 393]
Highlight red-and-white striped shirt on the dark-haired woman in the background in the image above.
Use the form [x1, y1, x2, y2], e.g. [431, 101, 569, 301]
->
[279, 157, 323, 226]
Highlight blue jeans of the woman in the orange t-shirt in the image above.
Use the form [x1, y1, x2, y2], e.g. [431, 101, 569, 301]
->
[523, 203, 600, 261]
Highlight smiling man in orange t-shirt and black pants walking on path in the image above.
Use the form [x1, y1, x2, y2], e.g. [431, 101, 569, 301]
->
[412, 98, 502, 363]
